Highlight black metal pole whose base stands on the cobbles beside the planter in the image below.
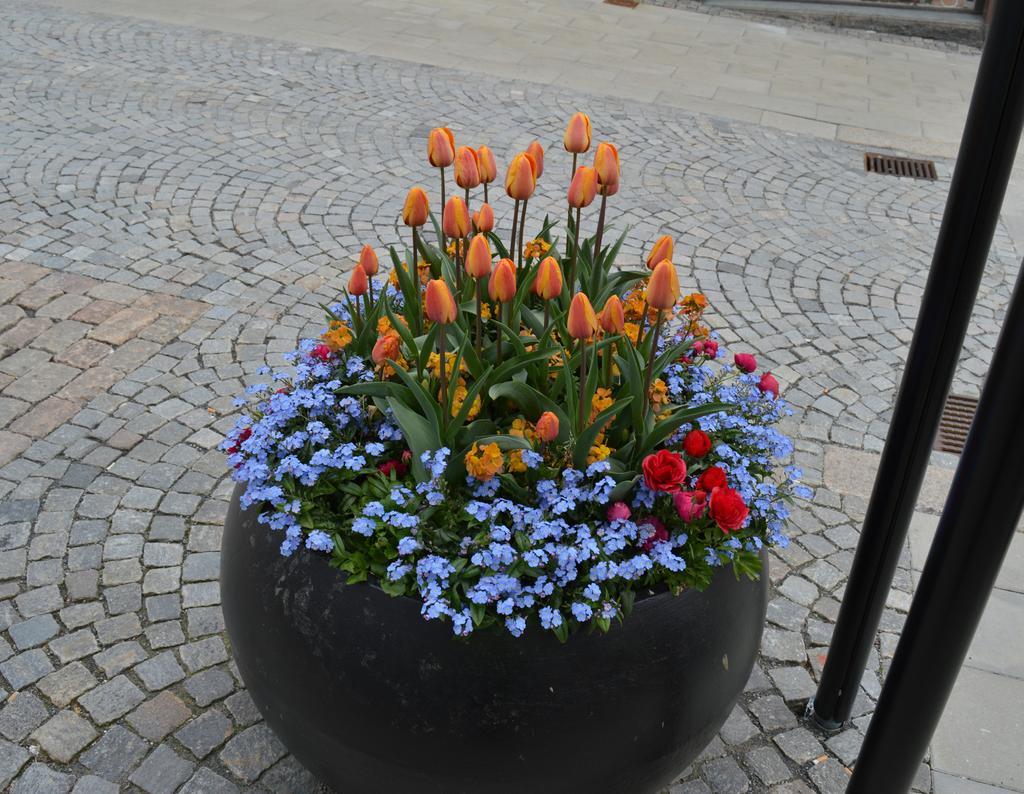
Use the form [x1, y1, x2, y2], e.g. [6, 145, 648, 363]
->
[811, 2, 1024, 729]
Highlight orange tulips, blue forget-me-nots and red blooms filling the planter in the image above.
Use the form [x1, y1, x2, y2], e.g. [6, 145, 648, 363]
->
[222, 113, 802, 640]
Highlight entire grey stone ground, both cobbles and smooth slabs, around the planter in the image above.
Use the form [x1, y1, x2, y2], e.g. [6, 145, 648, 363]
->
[6, 0, 1024, 794]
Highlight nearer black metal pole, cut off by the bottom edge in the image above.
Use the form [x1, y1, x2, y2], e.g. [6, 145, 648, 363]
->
[847, 258, 1024, 794]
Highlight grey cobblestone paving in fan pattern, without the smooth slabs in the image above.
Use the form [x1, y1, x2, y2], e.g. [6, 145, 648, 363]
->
[0, 2, 1016, 794]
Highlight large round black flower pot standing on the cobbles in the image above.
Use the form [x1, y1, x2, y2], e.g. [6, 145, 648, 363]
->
[220, 483, 767, 794]
